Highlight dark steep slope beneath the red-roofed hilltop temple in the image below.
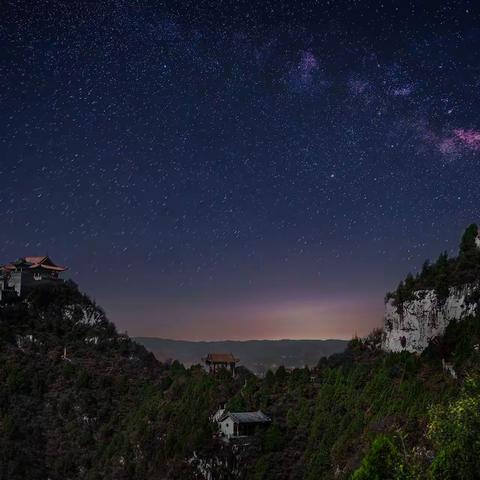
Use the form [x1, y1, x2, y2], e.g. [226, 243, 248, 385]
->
[0, 283, 171, 480]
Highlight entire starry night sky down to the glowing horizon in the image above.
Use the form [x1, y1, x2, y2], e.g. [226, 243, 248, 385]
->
[0, 0, 480, 340]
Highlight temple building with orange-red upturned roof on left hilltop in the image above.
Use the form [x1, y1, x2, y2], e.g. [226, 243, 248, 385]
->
[0, 256, 67, 300]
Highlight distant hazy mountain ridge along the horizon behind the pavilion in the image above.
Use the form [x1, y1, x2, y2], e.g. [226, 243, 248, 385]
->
[135, 337, 348, 375]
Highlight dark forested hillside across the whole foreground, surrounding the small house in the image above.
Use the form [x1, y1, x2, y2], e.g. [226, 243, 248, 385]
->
[0, 283, 480, 480]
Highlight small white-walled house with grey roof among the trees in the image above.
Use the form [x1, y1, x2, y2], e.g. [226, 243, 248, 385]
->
[217, 410, 272, 441]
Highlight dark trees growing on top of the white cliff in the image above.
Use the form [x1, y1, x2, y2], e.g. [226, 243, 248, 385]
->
[386, 224, 480, 308]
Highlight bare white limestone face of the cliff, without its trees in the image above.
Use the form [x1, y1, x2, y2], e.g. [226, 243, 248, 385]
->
[382, 286, 478, 353]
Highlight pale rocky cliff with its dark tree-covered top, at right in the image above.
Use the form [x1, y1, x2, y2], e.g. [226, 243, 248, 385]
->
[382, 224, 480, 353]
